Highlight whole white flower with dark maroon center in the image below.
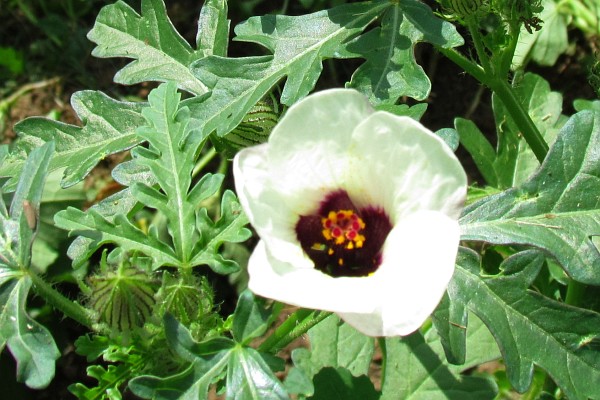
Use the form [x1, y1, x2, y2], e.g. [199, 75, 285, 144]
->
[234, 89, 467, 336]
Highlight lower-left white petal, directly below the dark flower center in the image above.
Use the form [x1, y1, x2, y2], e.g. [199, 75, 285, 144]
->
[248, 241, 381, 314]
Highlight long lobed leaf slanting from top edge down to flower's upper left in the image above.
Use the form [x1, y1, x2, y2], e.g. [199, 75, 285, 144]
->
[184, 1, 390, 136]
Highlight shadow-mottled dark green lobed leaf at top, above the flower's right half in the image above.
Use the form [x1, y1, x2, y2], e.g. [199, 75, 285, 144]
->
[347, 0, 464, 105]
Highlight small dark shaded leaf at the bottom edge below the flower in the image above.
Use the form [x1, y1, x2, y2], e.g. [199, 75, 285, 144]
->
[310, 367, 379, 400]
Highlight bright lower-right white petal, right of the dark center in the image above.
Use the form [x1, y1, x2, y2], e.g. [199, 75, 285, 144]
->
[340, 211, 459, 336]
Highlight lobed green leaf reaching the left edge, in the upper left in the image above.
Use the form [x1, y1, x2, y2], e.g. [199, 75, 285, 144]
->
[0, 91, 144, 190]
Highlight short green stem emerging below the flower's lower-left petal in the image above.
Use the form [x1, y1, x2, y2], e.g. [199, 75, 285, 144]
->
[258, 309, 331, 353]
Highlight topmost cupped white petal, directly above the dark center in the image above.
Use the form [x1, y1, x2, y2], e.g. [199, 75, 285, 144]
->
[268, 89, 373, 215]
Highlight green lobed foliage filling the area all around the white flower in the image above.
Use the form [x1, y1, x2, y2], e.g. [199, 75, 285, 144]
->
[0, 0, 600, 399]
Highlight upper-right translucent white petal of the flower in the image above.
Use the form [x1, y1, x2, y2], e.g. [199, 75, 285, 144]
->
[346, 112, 467, 222]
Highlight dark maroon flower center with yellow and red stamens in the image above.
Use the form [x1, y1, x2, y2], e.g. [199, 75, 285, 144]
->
[296, 190, 392, 277]
